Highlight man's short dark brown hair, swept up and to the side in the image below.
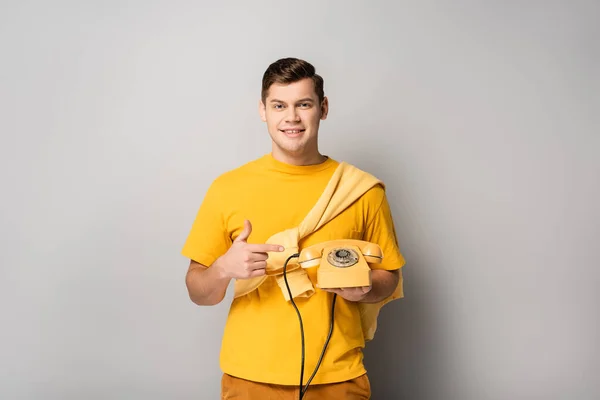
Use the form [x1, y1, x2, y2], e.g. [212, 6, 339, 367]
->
[261, 58, 325, 103]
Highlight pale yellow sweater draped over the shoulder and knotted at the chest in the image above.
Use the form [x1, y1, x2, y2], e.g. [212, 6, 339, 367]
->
[234, 162, 404, 340]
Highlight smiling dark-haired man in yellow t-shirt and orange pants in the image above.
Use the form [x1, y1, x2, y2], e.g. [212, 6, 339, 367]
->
[183, 58, 404, 400]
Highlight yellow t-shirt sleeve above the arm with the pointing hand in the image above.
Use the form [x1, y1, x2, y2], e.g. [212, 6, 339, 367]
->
[181, 180, 232, 267]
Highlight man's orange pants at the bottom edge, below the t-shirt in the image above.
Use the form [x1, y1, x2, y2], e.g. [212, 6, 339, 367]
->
[221, 374, 371, 400]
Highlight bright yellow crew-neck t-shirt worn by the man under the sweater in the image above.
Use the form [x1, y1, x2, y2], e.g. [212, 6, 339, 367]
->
[182, 154, 405, 385]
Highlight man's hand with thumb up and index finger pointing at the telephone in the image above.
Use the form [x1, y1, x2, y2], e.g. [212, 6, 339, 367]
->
[214, 220, 284, 279]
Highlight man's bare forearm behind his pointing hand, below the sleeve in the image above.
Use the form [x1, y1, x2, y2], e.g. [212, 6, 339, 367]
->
[185, 260, 231, 306]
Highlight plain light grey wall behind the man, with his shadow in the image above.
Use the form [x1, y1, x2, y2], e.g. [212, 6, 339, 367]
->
[0, 1, 600, 400]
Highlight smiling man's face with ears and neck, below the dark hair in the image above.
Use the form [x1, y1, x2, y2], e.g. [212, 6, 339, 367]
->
[260, 78, 328, 158]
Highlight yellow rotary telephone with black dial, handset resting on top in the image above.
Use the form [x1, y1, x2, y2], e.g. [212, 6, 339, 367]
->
[298, 239, 383, 288]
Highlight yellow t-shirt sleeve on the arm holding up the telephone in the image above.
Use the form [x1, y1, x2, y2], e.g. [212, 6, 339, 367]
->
[363, 187, 406, 270]
